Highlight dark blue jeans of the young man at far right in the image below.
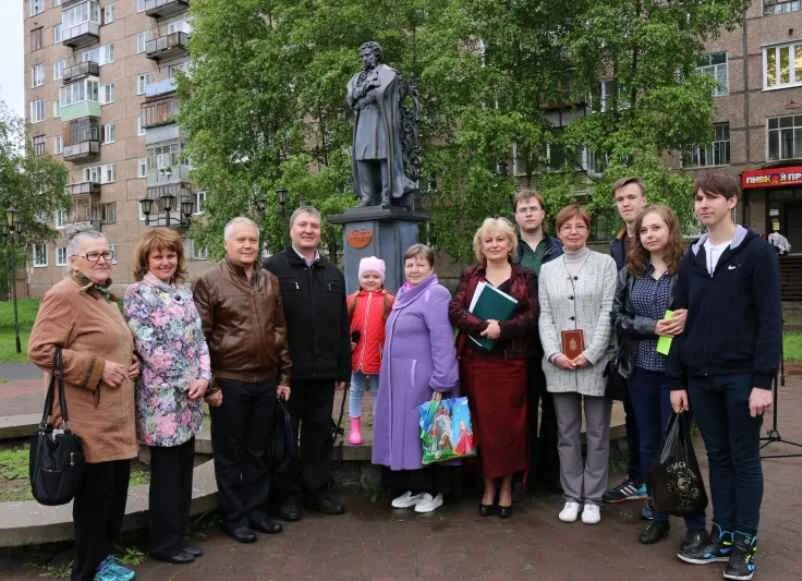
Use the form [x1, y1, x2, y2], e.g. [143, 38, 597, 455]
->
[688, 375, 763, 536]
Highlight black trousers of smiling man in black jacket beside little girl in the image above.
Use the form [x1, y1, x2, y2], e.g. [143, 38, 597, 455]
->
[276, 379, 334, 501]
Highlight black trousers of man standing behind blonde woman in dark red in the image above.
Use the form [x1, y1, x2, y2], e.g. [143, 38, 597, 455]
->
[527, 359, 560, 489]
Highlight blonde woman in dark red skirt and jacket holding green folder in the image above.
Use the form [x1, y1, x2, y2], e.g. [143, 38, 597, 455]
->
[449, 218, 538, 518]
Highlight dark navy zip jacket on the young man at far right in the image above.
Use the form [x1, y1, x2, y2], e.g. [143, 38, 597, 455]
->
[667, 226, 782, 389]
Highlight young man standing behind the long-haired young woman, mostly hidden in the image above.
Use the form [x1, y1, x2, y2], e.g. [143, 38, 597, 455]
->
[603, 176, 653, 506]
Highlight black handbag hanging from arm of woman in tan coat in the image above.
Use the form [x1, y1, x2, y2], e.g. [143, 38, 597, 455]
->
[28, 347, 84, 506]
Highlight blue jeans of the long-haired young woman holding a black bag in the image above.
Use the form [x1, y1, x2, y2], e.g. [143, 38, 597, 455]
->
[629, 367, 705, 530]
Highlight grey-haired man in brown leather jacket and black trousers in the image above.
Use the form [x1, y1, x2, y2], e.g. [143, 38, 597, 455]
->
[194, 217, 292, 543]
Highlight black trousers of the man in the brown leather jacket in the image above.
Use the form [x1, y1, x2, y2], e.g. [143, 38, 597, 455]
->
[211, 379, 276, 528]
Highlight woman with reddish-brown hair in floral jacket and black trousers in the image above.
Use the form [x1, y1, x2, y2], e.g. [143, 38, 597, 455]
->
[124, 228, 212, 563]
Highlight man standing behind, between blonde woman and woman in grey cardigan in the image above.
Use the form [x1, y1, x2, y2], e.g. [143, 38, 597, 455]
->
[513, 189, 563, 492]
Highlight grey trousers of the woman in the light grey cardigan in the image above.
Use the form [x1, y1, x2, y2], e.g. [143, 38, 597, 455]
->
[554, 393, 611, 504]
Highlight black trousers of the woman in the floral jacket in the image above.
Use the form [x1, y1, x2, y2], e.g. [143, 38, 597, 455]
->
[148, 438, 195, 555]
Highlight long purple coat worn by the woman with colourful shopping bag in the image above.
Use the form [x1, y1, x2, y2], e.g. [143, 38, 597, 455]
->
[372, 275, 458, 470]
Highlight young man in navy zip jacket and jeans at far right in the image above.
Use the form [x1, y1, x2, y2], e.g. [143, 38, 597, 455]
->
[668, 171, 782, 580]
